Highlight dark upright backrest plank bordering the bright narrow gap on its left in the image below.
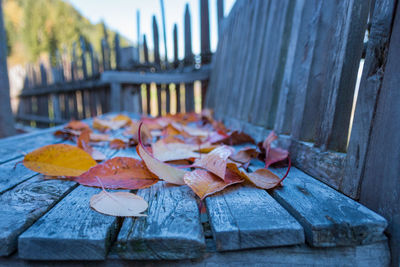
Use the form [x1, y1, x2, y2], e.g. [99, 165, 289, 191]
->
[314, 1, 369, 151]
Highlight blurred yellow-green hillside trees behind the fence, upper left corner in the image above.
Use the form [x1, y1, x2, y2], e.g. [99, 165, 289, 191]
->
[3, 0, 129, 66]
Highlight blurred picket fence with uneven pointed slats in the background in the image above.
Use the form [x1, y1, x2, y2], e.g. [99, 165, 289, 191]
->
[16, 0, 223, 127]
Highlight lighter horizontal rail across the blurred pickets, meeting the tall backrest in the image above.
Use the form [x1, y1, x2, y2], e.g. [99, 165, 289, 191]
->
[101, 66, 211, 84]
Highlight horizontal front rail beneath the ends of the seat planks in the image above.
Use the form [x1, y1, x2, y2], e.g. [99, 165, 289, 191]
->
[0, 241, 390, 267]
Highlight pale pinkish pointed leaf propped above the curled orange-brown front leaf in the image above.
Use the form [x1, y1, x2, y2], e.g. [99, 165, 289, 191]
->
[193, 146, 234, 179]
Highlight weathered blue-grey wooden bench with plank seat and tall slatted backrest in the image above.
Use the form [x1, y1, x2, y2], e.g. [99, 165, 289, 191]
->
[0, 0, 400, 266]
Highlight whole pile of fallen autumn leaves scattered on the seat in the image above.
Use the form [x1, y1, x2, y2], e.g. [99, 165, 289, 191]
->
[23, 110, 290, 217]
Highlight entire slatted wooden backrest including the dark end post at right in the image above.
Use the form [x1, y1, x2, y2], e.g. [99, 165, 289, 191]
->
[206, 0, 400, 266]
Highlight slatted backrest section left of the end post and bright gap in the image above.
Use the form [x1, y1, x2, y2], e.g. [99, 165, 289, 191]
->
[207, 0, 369, 197]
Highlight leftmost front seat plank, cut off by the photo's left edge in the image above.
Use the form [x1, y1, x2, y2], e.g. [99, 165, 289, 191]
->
[0, 175, 75, 256]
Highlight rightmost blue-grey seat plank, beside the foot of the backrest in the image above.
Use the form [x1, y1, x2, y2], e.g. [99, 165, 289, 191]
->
[272, 167, 387, 247]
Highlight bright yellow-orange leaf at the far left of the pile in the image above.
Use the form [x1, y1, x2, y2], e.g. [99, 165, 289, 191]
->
[23, 144, 96, 176]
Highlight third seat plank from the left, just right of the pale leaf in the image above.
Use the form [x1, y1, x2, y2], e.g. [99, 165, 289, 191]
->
[113, 182, 205, 260]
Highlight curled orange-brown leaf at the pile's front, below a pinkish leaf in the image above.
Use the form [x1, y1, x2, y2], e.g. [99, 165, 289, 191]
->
[183, 169, 244, 199]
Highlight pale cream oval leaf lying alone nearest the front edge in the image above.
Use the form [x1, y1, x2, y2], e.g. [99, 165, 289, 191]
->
[90, 190, 148, 217]
